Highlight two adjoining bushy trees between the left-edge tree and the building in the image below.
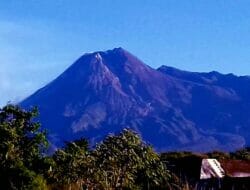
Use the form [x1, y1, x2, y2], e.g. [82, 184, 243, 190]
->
[51, 129, 172, 189]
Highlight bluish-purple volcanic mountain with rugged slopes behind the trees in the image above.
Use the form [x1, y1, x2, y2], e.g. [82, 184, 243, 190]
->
[21, 48, 250, 151]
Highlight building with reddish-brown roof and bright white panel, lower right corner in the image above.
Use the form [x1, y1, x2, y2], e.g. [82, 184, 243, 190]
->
[195, 159, 250, 190]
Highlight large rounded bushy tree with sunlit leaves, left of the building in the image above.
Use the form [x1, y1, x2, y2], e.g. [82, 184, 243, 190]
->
[93, 129, 168, 189]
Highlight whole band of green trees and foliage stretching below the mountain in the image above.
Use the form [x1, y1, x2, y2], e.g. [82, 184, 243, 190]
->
[0, 105, 250, 190]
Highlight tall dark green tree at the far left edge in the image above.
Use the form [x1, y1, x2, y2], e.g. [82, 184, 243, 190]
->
[0, 105, 48, 189]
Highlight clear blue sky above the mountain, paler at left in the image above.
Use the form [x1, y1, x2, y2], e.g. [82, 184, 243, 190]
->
[0, 0, 250, 106]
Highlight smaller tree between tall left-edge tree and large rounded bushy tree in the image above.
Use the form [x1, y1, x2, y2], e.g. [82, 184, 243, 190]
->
[50, 139, 93, 188]
